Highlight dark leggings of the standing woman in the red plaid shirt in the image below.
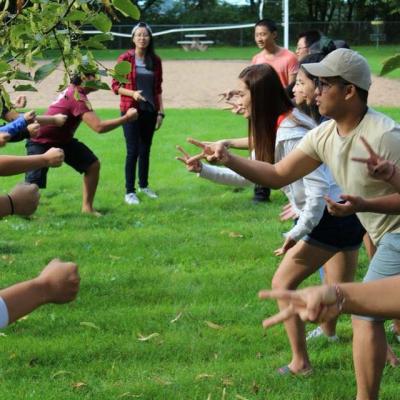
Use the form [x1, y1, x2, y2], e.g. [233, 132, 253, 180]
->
[123, 111, 157, 193]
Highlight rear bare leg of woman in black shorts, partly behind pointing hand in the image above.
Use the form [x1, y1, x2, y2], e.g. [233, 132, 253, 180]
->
[320, 250, 358, 336]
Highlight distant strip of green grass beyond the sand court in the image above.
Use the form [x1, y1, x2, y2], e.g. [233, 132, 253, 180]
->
[43, 45, 400, 78]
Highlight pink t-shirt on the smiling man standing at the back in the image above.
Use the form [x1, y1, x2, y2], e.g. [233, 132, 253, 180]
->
[251, 48, 299, 87]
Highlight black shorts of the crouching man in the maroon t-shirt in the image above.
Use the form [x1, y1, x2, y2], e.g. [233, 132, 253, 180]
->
[25, 139, 98, 188]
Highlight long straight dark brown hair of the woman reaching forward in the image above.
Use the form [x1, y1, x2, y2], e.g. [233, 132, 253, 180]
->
[239, 64, 293, 163]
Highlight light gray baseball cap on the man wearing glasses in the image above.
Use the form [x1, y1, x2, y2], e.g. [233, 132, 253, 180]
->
[302, 49, 371, 91]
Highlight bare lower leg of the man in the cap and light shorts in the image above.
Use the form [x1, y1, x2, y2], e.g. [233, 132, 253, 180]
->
[353, 317, 387, 400]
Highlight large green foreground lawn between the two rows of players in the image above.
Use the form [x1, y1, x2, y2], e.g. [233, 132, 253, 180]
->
[0, 109, 400, 400]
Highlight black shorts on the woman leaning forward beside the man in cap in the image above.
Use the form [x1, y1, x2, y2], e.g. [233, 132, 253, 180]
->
[303, 207, 365, 251]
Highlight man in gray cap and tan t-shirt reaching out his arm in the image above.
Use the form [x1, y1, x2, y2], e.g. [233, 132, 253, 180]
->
[189, 49, 400, 400]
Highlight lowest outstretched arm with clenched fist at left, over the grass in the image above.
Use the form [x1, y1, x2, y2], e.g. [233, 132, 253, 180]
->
[0, 259, 80, 327]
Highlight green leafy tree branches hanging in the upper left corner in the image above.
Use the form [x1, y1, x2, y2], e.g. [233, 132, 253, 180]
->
[0, 0, 140, 112]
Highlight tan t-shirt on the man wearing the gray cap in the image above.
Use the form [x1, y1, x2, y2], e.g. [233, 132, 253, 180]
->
[297, 109, 400, 243]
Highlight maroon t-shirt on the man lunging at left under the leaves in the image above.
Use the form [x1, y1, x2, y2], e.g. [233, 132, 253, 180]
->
[32, 85, 92, 145]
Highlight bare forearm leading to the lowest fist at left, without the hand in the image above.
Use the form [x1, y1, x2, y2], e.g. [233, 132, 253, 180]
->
[0, 279, 46, 324]
